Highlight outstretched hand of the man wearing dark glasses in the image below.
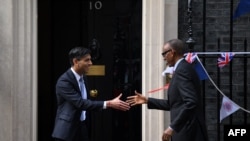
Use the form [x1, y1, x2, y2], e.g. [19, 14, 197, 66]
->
[126, 91, 148, 106]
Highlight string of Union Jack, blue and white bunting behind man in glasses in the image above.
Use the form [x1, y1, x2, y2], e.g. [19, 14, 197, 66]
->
[148, 52, 250, 122]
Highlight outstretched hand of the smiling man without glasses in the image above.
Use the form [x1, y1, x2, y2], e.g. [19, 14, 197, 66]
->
[107, 94, 130, 111]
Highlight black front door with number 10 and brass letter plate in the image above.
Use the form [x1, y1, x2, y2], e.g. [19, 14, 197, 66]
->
[38, 0, 142, 141]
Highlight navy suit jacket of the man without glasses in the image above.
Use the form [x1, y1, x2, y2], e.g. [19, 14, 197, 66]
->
[52, 69, 104, 140]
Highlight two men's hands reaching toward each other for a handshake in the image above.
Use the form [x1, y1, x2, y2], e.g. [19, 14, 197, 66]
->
[106, 91, 148, 111]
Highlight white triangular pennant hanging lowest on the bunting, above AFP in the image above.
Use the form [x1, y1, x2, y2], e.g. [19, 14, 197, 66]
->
[220, 96, 240, 122]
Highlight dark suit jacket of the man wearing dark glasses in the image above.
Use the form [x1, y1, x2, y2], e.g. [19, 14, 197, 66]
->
[148, 59, 207, 141]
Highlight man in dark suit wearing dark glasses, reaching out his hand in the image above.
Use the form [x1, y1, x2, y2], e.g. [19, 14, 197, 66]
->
[127, 39, 208, 141]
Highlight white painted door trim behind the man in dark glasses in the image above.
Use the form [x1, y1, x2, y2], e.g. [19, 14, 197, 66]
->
[142, 0, 178, 141]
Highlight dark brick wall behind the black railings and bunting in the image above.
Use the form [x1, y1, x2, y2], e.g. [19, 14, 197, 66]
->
[178, 0, 250, 141]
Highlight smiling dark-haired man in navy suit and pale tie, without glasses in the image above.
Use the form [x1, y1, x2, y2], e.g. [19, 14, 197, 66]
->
[52, 47, 130, 141]
